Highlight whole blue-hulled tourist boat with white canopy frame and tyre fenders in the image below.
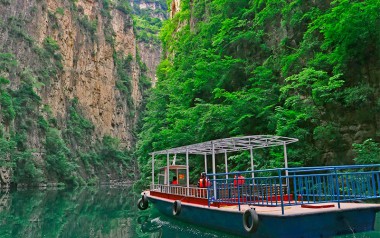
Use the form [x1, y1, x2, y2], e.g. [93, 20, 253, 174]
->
[137, 135, 380, 238]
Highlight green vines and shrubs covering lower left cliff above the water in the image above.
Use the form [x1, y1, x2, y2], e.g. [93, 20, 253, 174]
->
[0, 52, 133, 185]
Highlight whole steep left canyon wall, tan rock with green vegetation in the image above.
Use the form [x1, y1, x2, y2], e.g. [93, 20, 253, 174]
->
[0, 0, 166, 186]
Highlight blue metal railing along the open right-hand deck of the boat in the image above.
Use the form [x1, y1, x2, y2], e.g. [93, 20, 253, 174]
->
[207, 164, 380, 214]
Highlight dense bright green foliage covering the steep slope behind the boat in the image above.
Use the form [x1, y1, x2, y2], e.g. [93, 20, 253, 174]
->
[138, 0, 380, 184]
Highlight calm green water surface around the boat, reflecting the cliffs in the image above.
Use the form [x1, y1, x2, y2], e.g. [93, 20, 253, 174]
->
[0, 188, 380, 238]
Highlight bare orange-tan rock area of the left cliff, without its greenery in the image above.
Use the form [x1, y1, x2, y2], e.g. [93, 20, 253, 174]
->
[1, 0, 141, 146]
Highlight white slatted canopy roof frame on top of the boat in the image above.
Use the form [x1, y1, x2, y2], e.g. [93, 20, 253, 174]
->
[150, 135, 298, 155]
